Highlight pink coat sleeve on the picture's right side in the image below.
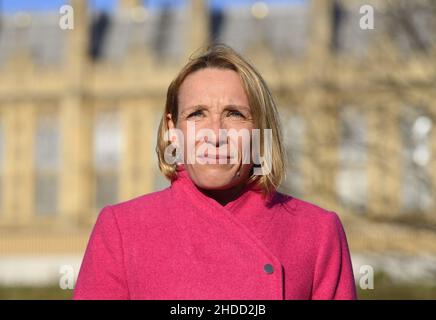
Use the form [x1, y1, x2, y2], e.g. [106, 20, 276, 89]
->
[312, 212, 357, 300]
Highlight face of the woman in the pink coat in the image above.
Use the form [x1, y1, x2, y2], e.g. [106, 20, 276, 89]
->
[167, 68, 254, 190]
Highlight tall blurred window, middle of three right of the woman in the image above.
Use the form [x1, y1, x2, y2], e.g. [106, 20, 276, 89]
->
[337, 107, 368, 212]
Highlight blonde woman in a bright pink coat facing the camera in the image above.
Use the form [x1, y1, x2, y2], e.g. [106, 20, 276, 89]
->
[74, 45, 356, 300]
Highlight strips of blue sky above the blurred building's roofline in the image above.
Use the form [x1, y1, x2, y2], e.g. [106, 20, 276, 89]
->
[0, 0, 305, 13]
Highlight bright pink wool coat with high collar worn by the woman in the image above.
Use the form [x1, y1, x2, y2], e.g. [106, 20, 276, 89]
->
[74, 166, 356, 300]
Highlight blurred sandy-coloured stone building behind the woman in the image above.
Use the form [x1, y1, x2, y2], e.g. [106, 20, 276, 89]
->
[0, 0, 436, 283]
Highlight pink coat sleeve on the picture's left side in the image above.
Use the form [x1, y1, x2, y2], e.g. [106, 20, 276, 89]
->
[73, 206, 129, 300]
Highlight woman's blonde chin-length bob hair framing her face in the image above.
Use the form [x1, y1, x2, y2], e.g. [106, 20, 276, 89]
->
[156, 44, 286, 195]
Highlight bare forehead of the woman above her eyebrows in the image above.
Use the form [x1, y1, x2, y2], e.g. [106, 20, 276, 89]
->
[178, 68, 248, 108]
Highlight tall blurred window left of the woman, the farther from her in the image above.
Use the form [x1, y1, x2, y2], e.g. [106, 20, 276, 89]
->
[34, 112, 60, 215]
